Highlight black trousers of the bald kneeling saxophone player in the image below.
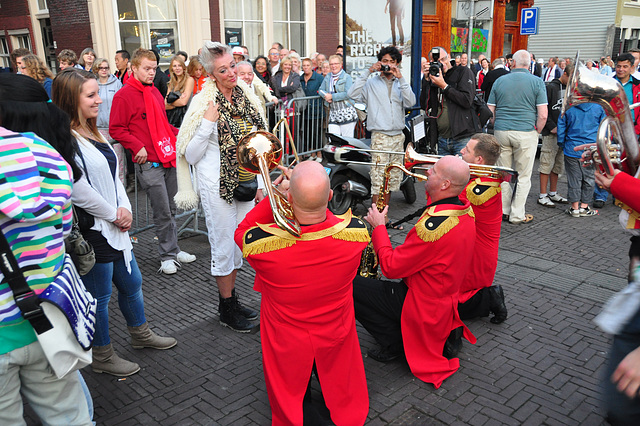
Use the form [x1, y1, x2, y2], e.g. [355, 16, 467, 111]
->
[353, 275, 409, 348]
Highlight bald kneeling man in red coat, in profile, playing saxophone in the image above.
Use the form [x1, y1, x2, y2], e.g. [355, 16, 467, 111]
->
[354, 156, 476, 388]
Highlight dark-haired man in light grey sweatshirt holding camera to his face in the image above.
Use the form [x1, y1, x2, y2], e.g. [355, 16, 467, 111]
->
[349, 46, 416, 210]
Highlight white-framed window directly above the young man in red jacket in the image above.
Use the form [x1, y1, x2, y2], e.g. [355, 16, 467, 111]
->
[117, 0, 180, 64]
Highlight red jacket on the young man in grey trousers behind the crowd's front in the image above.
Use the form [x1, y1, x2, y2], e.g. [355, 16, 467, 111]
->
[109, 81, 178, 163]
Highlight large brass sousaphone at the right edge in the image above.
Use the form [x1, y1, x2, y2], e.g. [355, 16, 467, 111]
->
[562, 52, 640, 176]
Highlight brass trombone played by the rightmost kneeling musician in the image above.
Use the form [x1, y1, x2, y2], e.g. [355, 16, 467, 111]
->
[334, 142, 518, 183]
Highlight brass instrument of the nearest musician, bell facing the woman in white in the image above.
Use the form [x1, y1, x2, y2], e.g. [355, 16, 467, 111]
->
[237, 130, 301, 237]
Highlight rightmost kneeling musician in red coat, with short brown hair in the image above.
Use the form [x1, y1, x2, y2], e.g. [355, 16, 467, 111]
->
[458, 133, 507, 324]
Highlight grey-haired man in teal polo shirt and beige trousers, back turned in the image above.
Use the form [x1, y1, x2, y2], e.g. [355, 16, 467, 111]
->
[487, 50, 547, 223]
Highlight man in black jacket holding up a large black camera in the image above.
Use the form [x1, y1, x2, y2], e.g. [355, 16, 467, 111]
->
[420, 47, 480, 155]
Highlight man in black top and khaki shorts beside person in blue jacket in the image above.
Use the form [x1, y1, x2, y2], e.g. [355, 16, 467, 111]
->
[538, 65, 573, 207]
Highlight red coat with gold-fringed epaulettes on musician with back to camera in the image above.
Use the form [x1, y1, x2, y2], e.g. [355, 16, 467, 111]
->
[235, 199, 369, 425]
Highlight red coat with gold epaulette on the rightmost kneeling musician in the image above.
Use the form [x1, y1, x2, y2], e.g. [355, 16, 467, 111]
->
[459, 177, 502, 303]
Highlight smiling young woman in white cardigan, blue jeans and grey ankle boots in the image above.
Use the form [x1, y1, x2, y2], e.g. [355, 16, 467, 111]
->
[52, 69, 177, 376]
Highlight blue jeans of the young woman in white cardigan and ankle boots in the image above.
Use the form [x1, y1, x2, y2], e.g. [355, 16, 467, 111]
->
[82, 252, 147, 346]
